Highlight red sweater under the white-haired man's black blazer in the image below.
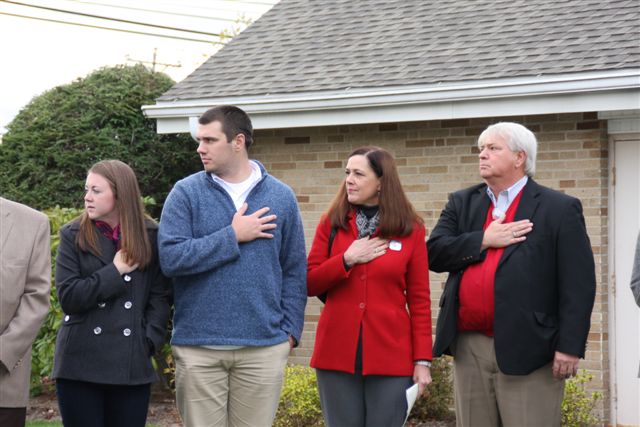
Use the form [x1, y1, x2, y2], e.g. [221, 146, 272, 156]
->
[458, 191, 522, 336]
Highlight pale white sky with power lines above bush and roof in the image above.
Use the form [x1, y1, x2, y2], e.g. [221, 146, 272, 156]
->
[0, 0, 278, 134]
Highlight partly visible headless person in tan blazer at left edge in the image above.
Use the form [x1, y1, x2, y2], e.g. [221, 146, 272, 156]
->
[0, 197, 51, 427]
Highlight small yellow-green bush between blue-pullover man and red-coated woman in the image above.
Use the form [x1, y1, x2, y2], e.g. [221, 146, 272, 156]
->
[273, 365, 324, 427]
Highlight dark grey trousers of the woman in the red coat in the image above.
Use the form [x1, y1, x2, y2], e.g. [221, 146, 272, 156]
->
[316, 369, 413, 427]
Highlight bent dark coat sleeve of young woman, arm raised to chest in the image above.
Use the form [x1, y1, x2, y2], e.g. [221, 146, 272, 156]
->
[56, 226, 126, 314]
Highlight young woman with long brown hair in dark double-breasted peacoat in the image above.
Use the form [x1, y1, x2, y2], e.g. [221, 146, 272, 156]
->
[53, 160, 170, 427]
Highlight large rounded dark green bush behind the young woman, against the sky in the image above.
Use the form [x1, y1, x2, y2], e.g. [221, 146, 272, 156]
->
[0, 65, 201, 217]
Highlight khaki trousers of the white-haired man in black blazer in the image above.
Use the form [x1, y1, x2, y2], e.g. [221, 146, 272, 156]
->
[453, 332, 564, 427]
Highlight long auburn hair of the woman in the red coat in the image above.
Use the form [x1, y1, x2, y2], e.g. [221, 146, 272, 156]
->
[326, 147, 424, 238]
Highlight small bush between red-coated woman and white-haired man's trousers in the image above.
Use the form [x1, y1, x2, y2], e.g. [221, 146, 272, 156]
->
[409, 357, 453, 423]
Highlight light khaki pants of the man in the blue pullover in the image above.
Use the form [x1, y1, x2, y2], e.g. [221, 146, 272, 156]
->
[172, 342, 289, 427]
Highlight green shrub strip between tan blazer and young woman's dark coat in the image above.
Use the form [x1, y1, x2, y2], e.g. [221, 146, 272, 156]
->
[31, 206, 81, 394]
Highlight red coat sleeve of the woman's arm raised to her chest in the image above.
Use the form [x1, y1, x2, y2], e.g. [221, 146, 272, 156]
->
[307, 216, 349, 296]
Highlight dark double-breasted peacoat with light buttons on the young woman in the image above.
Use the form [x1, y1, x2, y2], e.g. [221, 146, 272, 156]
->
[52, 220, 171, 385]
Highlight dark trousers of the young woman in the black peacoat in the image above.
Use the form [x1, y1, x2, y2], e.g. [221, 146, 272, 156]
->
[56, 379, 151, 427]
